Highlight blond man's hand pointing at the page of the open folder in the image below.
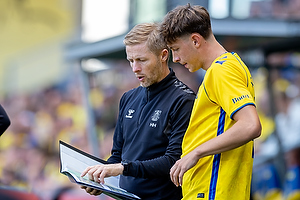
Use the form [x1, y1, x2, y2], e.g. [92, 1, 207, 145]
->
[81, 163, 124, 183]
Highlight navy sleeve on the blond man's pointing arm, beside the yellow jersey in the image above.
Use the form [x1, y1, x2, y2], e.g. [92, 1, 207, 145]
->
[126, 95, 194, 178]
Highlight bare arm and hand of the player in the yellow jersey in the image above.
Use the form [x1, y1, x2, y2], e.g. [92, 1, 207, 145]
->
[170, 105, 261, 186]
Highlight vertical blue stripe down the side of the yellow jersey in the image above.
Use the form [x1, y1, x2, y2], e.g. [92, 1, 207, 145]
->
[208, 108, 226, 200]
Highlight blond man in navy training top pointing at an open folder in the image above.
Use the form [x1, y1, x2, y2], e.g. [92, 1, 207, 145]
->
[82, 23, 195, 200]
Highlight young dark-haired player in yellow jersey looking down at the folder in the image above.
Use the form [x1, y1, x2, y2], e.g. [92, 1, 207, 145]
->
[161, 4, 261, 200]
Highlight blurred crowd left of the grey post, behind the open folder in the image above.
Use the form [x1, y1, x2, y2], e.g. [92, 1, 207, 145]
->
[0, 79, 88, 199]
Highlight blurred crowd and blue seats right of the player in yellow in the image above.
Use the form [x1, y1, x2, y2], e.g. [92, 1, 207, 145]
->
[252, 52, 300, 200]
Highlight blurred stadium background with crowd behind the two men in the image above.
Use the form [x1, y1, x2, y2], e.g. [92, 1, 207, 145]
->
[0, 0, 300, 200]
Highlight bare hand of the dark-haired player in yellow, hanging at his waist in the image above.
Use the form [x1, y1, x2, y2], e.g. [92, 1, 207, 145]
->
[170, 152, 198, 187]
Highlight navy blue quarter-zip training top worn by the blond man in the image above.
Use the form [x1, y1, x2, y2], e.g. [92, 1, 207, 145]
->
[108, 69, 195, 200]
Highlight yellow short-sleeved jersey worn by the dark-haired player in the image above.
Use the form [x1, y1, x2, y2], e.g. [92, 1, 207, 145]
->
[182, 53, 255, 200]
